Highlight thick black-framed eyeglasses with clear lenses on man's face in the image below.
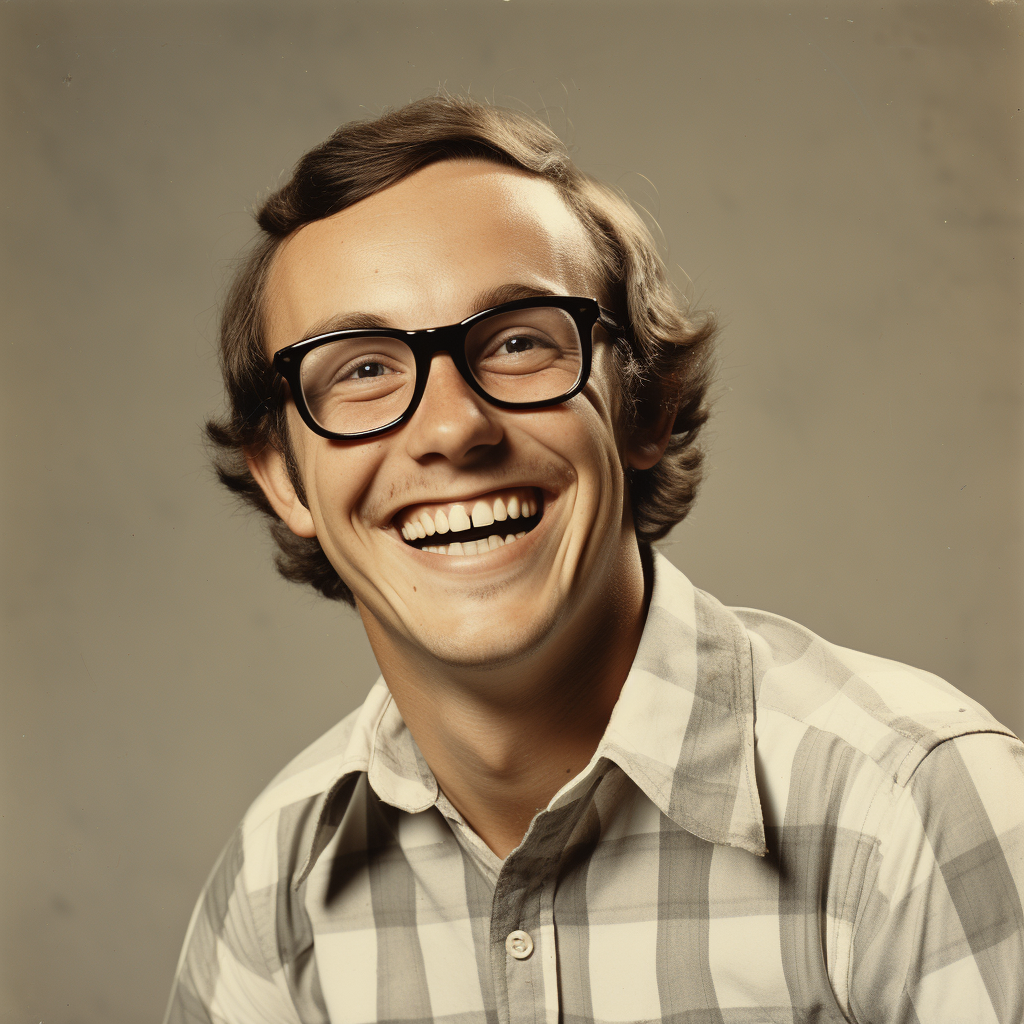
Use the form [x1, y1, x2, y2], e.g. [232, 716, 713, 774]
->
[273, 296, 622, 440]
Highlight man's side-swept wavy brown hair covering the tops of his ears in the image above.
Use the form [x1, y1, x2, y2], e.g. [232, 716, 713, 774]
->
[206, 96, 717, 604]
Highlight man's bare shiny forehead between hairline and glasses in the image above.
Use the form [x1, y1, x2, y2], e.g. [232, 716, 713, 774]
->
[265, 160, 597, 351]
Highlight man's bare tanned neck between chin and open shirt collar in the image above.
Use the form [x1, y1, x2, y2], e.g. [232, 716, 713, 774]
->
[365, 547, 649, 858]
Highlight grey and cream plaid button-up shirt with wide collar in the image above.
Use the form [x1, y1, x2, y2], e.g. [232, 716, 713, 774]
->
[167, 555, 1024, 1024]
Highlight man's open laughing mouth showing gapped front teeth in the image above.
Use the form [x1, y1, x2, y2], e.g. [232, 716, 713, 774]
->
[394, 487, 544, 555]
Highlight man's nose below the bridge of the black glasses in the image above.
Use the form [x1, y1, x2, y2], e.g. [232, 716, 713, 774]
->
[402, 352, 505, 464]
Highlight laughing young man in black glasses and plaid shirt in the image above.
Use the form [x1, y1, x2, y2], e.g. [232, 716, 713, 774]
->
[168, 99, 1024, 1024]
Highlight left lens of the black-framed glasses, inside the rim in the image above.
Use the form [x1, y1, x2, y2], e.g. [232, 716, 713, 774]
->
[299, 337, 416, 434]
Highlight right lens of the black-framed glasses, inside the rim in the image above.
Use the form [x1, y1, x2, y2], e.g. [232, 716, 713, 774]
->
[466, 306, 583, 401]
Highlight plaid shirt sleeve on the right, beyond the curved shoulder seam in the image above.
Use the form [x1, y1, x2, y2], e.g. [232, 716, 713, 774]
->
[850, 733, 1024, 1024]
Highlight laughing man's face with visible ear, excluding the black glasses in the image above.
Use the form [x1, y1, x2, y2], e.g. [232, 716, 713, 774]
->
[253, 161, 655, 668]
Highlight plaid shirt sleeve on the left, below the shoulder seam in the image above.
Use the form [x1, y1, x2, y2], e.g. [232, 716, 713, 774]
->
[164, 829, 300, 1024]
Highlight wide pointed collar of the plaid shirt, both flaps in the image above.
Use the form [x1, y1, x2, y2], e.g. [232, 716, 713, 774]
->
[295, 552, 766, 886]
